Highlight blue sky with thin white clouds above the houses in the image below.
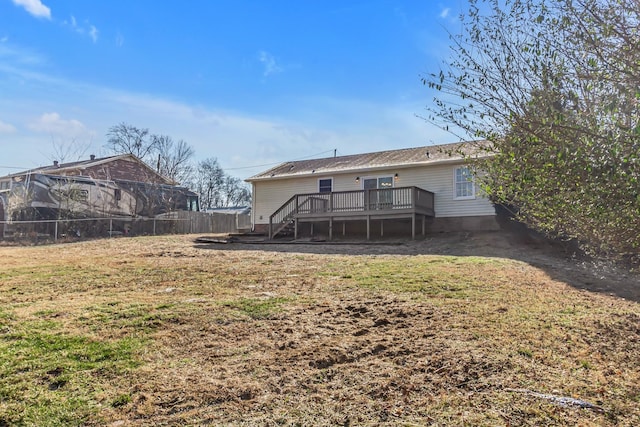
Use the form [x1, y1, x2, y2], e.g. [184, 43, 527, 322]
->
[0, 0, 466, 178]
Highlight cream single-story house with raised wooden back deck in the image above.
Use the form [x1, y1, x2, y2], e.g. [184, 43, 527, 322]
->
[246, 141, 498, 239]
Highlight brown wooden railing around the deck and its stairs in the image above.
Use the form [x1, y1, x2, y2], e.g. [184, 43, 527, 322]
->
[269, 187, 434, 238]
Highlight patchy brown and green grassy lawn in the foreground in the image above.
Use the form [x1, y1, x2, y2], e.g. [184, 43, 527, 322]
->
[0, 236, 640, 427]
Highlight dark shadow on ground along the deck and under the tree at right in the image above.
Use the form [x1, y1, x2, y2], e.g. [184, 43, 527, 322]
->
[195, 230, 640, 302]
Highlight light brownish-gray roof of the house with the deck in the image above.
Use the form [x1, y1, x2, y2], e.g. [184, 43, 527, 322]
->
[246, 141, 489, 182]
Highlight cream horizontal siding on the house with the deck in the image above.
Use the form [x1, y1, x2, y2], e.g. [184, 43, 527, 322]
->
[252, 163, 495, 224]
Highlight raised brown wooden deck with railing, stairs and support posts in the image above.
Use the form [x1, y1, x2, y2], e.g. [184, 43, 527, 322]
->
[269, 187, 435, 239]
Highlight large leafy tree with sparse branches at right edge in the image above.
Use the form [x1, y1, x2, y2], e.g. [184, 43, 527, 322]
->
[423, 0, 640, 261]
